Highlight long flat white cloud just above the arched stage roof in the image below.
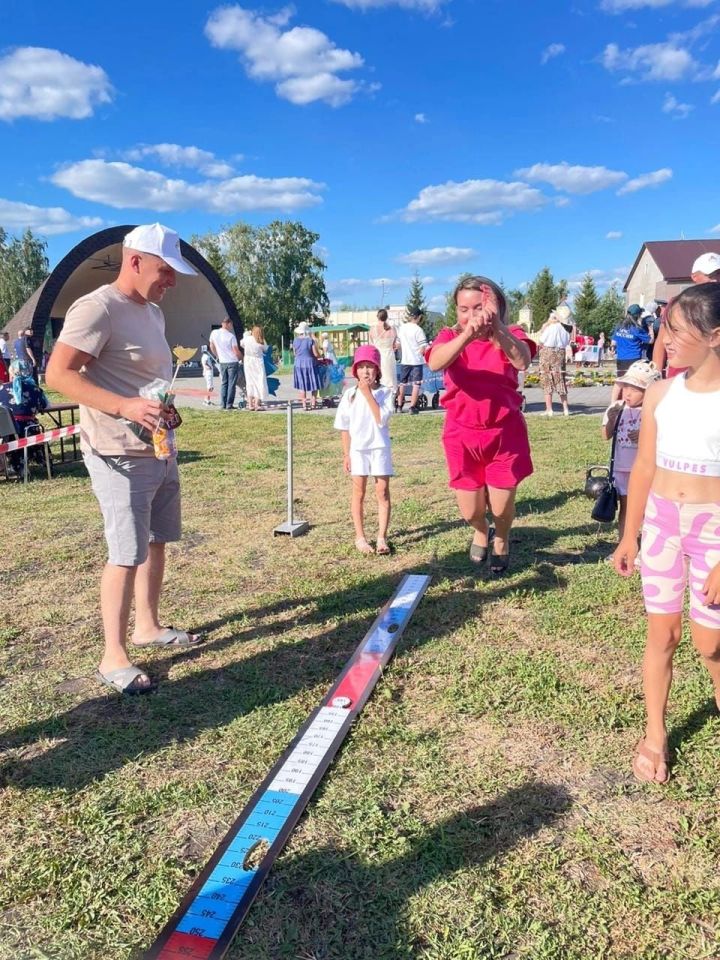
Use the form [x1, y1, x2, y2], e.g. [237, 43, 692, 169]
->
[51, 160, 324, 213]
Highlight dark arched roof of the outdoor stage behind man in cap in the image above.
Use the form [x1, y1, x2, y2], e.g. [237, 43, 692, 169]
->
[6, 224, 242, 345]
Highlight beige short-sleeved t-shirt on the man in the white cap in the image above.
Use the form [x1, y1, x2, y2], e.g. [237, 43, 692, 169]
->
[58, 284, 172, 457]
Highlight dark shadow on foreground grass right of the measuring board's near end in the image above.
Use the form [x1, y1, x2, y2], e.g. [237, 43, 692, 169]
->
[222, 781, 572, 960]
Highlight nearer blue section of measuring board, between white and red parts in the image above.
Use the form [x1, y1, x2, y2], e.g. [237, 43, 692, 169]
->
[175, 790, 300, 940]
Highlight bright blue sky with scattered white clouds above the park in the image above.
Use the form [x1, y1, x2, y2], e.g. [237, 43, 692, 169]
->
[0, 0, 720, 306]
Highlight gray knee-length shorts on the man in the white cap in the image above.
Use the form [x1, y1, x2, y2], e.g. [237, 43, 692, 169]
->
[83, 451, 180, 567]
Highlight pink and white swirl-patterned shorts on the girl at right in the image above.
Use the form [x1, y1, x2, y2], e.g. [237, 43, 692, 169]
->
[640, 493, 720, 630]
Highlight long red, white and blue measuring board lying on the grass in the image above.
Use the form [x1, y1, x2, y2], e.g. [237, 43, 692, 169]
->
[145, 574, 430, 960]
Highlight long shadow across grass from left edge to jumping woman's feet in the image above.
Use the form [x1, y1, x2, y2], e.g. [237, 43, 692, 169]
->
[0, 528, 580, 791]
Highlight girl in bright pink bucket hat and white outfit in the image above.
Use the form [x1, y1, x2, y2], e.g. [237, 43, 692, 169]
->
[334, 344, 395, 554]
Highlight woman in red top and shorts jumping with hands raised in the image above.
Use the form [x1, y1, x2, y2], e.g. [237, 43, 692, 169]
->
[427, 277, 537, 574]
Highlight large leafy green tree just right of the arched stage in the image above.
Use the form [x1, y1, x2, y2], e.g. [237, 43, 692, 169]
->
[193, 220, 330, 343]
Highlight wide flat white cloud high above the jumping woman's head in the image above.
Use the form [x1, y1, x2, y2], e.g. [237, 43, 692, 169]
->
[400, 180, 547, 226]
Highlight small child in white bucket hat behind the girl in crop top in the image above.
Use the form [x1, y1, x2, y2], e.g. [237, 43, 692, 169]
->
[602, 360, 660, 540]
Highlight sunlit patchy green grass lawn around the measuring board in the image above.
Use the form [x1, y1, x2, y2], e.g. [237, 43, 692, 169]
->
[0, 410, 720, 960]
